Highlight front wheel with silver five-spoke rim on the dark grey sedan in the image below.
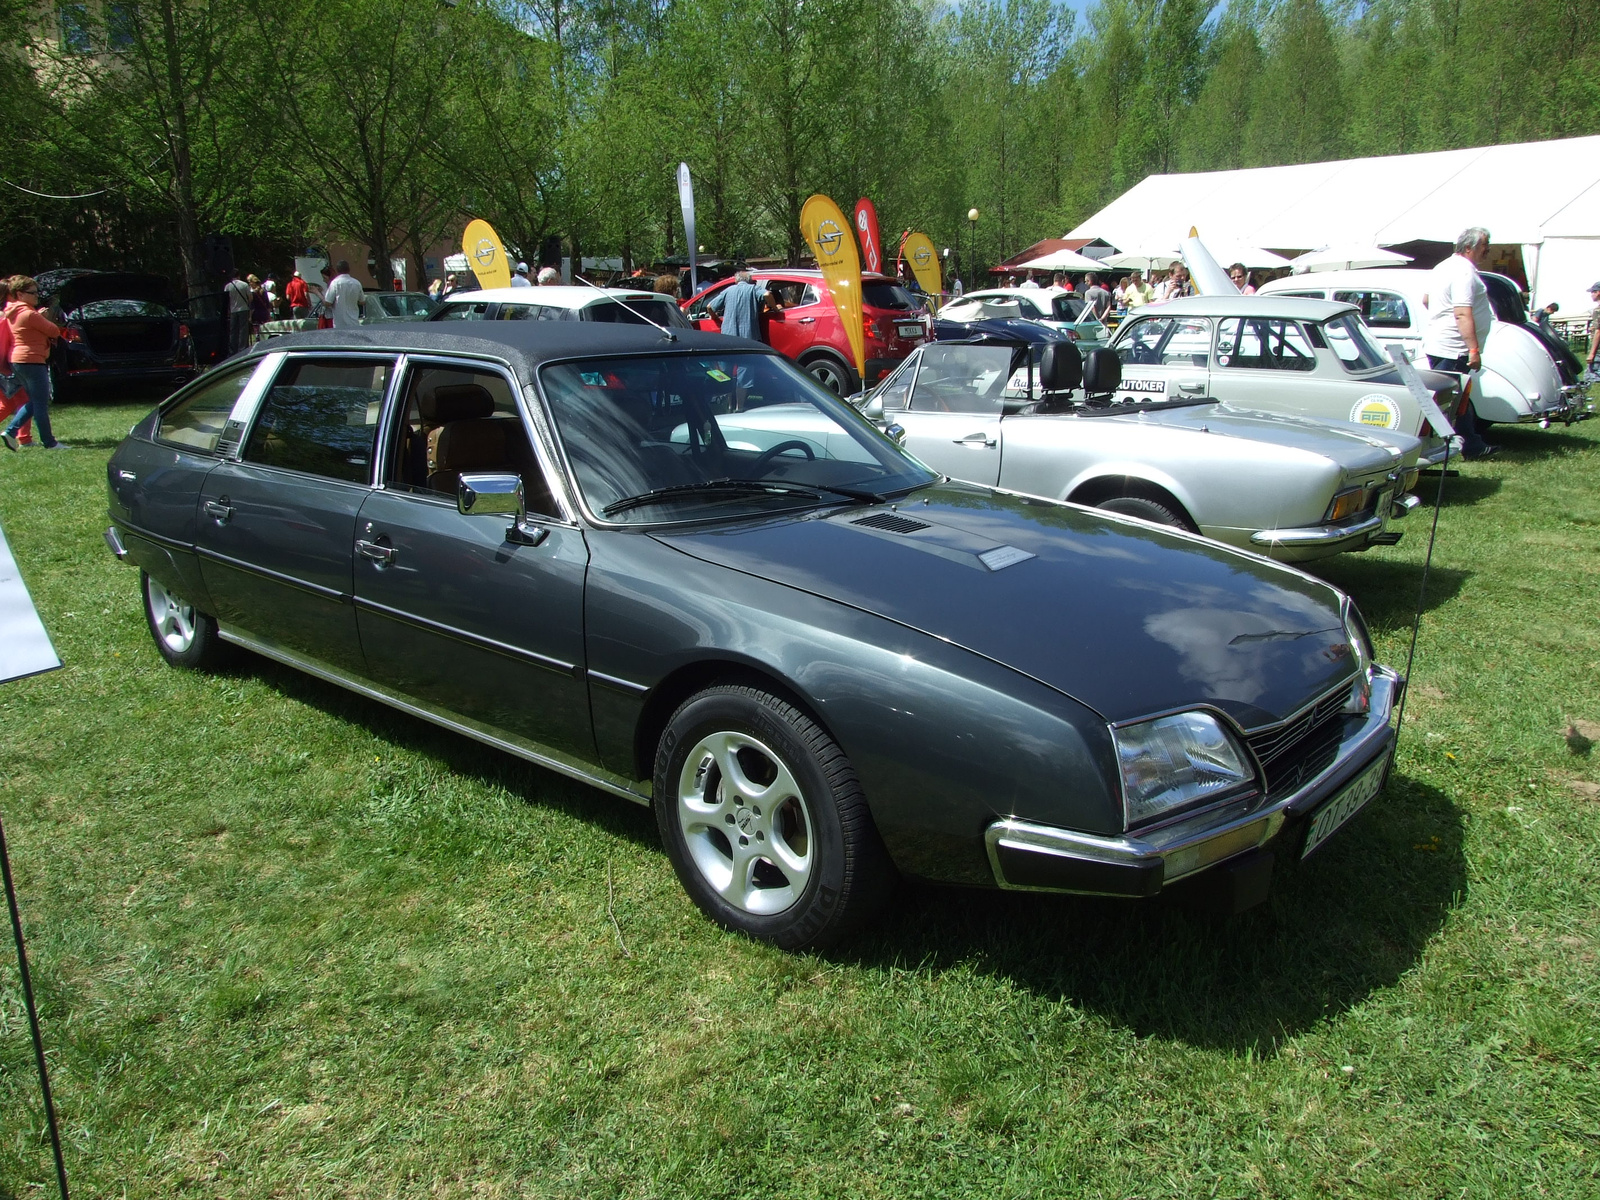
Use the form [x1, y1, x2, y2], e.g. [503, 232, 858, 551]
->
[654, 685, 894, 950]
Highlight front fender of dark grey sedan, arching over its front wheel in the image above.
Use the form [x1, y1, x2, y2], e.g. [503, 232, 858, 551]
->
[584, 533, 1122, 883]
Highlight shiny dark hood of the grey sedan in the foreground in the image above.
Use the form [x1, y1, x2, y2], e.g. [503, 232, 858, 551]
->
[654, 483, 1355, 730]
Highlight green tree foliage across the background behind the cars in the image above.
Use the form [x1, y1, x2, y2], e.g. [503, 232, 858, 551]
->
[0, 0, 1600, 290]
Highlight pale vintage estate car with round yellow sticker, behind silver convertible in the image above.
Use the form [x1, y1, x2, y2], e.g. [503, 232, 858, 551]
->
[1112, 296, 1461, 462]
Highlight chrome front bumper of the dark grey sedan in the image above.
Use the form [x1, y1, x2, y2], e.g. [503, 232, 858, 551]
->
[984, 667, 1405, 896]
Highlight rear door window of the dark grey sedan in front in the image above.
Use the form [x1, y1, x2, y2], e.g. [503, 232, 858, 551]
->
[243, 357, 394, 483]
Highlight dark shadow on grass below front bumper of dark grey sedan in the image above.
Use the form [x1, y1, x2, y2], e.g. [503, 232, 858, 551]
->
[829, 774, 1467, 1054]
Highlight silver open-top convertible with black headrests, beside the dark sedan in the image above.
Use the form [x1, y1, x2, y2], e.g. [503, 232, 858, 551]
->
[862, 341, 1421, 562]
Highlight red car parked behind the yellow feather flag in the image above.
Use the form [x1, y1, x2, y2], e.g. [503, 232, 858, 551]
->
[683, 267, 931, 395]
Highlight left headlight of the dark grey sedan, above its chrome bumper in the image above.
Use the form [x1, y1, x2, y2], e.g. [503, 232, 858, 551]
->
[1112, 712, 1256, 826]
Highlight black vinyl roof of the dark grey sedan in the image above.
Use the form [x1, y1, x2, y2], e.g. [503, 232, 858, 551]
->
[230, 322, 771, 379]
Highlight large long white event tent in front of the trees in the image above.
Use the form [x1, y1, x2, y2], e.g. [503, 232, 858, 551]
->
[1067, 136, 1600, 317]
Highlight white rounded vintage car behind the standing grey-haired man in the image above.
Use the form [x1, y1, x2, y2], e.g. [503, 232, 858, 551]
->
[1261, 269, 1589, 426]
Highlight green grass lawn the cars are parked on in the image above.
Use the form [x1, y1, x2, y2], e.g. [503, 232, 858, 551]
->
[0, 405, 1600, 1200]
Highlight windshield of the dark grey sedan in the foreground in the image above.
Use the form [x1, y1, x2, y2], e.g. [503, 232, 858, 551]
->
[539, 354, 938, 523]
